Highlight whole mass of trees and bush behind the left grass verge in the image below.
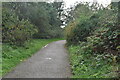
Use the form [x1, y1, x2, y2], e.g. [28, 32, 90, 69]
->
[2, 2, 63, 45]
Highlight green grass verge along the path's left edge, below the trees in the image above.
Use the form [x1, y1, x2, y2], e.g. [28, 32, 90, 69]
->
[2, 39, 61, 76]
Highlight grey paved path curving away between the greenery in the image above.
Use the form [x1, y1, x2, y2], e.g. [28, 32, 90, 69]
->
[5, 40, 71, 78]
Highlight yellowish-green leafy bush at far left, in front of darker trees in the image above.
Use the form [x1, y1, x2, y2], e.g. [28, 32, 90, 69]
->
[2, 8, 37, 45]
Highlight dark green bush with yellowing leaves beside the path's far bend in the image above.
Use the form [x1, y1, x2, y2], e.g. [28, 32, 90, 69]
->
[65, 14, 99, 44]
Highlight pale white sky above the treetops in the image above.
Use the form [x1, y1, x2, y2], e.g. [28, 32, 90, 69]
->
[63, 0, 111, 8]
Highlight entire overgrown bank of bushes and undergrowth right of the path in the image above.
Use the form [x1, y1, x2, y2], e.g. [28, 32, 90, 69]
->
[65, 3, 120, 78]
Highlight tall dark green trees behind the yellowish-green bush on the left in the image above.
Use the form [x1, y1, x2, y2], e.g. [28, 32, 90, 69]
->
[3, 2, 63, 38]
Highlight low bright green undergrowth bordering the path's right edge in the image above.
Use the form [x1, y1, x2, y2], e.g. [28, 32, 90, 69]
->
[68, 46, 118, 78]
